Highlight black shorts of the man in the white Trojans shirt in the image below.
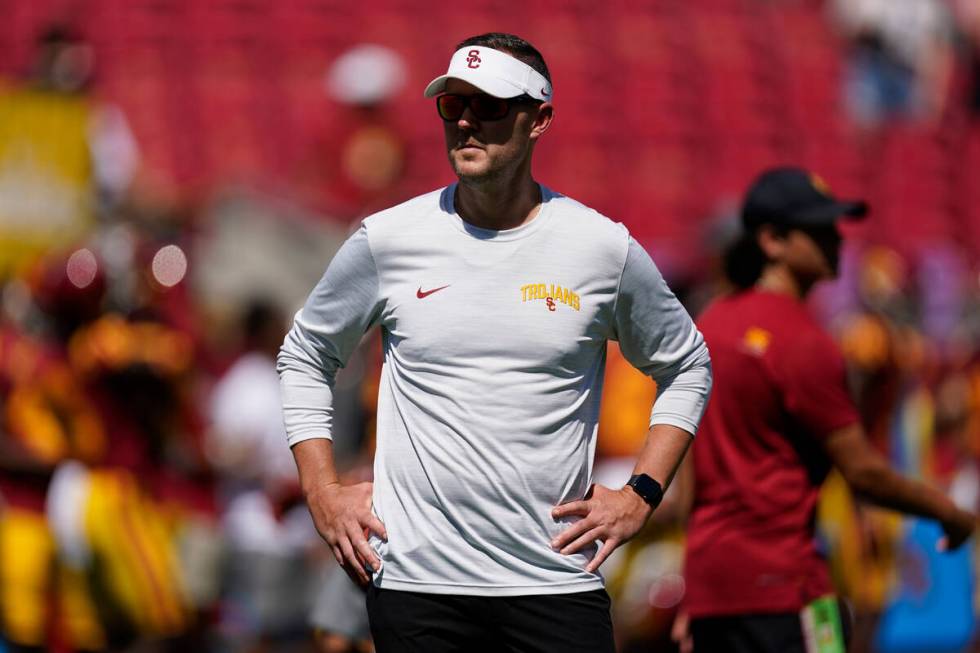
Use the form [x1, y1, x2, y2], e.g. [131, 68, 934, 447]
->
[367, 585, 616, 653]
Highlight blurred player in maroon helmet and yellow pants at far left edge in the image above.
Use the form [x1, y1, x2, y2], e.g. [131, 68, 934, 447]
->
[0, 256, 107, 651]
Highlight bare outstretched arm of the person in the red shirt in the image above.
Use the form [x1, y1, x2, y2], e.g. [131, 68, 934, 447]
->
[824, 424, 976, 549]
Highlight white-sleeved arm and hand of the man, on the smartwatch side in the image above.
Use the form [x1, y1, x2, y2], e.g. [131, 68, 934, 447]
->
[551, 238, 711, 572]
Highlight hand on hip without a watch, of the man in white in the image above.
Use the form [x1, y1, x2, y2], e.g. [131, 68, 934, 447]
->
[306, 483, 388, 585]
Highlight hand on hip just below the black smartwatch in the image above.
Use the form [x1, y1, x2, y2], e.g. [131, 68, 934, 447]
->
[551, 485, 653, 573]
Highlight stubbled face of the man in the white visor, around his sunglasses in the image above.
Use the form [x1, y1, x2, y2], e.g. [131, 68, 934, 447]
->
[443, 79, 550, 184]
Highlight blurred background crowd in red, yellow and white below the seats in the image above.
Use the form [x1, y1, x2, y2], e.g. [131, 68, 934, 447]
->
[0, 0, 980, 652]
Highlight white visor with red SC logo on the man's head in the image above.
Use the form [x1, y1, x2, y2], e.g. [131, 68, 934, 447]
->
[425, 45, 551, 102]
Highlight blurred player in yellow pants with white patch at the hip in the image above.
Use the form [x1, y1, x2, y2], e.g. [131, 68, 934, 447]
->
[48, 288, 207, 649]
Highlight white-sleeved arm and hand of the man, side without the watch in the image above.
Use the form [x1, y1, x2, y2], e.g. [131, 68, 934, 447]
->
[277, 227, 387, 584]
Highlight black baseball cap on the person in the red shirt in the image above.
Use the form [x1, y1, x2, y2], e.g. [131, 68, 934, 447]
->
[742, 166, 868, 229]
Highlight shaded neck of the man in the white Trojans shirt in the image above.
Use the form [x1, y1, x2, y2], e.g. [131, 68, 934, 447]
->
[455, 177, 542, 231]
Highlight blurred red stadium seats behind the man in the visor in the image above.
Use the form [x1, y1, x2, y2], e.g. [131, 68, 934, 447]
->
[0, 0, 980, 269]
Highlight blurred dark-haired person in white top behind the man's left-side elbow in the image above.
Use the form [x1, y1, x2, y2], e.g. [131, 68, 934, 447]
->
[206, 299, 320, 651]
